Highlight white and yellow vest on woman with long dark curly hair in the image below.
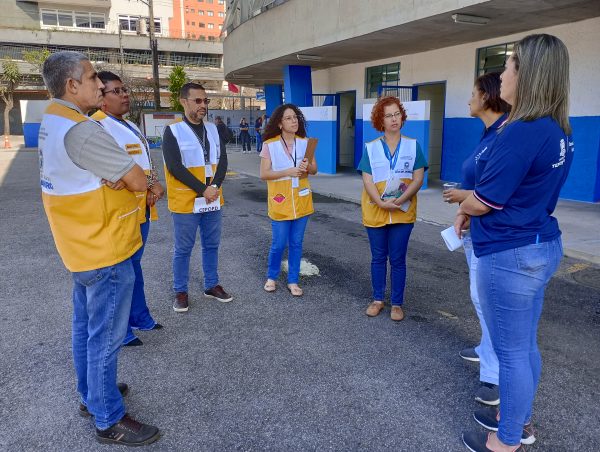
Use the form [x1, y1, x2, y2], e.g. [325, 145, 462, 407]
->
[265, 136, 315, 221]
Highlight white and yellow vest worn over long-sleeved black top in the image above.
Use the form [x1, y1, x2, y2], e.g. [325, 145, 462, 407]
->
[165, 120, 223, 213]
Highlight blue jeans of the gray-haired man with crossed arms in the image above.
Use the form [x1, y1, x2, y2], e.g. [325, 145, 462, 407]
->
[72, 259, 135, 430]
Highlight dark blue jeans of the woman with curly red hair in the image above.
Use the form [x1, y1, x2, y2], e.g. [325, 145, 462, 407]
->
[366, 223, 414, 306]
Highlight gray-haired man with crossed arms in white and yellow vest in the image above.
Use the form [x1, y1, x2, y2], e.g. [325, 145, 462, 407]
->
[39, 52, 160, 446]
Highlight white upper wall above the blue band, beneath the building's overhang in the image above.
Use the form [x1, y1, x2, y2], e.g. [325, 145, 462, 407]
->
[313, 18, 600, 118]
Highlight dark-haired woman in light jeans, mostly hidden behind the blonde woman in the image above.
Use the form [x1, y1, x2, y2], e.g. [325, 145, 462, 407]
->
[443, 73, 510, 405]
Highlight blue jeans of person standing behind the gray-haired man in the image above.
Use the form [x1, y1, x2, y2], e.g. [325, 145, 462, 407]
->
[123, 214, 156, 344]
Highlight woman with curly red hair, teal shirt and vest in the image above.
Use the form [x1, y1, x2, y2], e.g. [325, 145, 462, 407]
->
[358, 97, 427, 321]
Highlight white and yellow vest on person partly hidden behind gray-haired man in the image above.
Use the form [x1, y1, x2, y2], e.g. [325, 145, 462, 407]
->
[92, 110, 158, 223]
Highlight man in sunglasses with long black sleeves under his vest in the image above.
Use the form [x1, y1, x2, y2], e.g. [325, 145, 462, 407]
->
[162, 83, 233, 312]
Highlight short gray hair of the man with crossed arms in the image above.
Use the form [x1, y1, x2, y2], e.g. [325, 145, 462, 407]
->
[42, 51, 89, 99]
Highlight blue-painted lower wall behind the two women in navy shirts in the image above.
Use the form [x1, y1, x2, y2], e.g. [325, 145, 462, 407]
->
[441, 116, 600, 202]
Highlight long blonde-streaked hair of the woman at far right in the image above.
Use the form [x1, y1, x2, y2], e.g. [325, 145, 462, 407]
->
[508, 34, 571, 135]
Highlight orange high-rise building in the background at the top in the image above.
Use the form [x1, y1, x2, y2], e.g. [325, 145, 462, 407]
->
[169, 0, 226, 41]
